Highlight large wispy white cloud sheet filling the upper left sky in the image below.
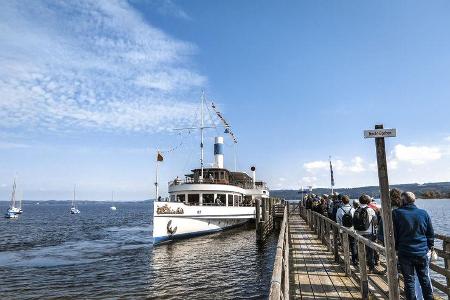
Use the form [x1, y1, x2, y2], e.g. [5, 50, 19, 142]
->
[0, 0, 207, 132]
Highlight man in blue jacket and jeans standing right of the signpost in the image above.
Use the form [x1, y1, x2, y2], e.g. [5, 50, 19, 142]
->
[392, 192, 434, 300]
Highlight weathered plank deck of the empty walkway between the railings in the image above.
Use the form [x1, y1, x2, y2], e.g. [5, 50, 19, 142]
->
[289, 214, 361, 300]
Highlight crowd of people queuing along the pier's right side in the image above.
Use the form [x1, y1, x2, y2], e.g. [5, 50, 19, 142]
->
[303, 189, 434, 300]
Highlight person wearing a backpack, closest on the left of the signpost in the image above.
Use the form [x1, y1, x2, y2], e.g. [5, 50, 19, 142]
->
[353, 195, 378, 273]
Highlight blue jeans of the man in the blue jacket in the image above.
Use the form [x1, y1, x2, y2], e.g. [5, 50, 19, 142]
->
[398, 255, 433, 300]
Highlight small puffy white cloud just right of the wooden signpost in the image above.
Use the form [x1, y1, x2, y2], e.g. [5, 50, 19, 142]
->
[393, 144, 442, 165]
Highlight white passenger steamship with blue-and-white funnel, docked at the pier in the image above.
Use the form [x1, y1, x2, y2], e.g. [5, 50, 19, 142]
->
[153, 97, 269, 244]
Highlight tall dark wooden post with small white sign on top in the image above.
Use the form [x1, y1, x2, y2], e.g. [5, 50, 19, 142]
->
[364, 125, 400, 299]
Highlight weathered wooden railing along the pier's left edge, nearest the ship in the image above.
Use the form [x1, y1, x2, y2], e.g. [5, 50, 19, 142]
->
[269, 202, 289, 300]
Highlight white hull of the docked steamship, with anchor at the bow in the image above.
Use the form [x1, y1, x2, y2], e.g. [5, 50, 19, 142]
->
[153, 202, 255, 244]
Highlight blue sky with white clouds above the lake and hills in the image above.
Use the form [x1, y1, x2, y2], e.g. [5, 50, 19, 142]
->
[0, 0, 450, 200]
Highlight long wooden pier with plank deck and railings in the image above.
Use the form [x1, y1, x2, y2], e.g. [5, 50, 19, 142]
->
[269, 201, 450, 299]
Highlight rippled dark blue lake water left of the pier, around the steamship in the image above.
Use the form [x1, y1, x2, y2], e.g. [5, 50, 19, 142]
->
[0, 202, 276, 299]
